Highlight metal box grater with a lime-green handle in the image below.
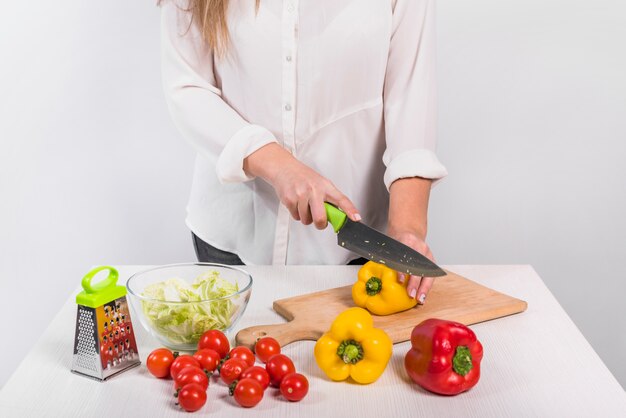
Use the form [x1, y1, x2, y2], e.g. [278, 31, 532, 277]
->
[72, 266, 141, 381]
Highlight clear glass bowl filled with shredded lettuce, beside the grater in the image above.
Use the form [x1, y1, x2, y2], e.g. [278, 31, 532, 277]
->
[126, 263, 252, 351]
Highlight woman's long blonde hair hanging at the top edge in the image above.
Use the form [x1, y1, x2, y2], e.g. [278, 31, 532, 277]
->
[162, 0, 260, 56]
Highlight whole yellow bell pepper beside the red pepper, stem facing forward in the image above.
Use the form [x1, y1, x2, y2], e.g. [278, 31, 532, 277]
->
[314, 307, 393, 384]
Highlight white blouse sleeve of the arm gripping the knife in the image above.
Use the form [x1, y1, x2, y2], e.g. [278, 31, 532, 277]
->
[161, 1, 276, 183]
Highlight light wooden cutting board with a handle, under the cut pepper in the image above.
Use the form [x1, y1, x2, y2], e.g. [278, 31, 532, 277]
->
[235, 271, 527, 348]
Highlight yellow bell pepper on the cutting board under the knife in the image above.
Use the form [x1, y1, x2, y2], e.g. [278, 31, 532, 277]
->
[352, 261, 417, 315]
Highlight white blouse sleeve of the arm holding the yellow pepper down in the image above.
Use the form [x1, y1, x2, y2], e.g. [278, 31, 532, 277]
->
[383, 0, 448, 189]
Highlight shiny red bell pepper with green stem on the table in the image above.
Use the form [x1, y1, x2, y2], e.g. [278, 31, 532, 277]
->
[404, 318, 483, 395]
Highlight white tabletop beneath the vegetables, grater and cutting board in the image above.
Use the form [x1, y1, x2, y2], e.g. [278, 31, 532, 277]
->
[0, 265, 626, 418]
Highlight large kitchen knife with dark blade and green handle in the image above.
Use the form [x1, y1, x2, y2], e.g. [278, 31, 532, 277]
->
[324, 202, 446, 277]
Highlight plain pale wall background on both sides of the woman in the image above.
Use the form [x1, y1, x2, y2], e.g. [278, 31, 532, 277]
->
[0, 0, 626, 387]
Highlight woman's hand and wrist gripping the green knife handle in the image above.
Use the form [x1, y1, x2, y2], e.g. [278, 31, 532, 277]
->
[243, 143, 361, 229]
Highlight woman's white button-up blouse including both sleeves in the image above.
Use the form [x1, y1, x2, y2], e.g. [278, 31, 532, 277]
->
[161, 0, 447, 264]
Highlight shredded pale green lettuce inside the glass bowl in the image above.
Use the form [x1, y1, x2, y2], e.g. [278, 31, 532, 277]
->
[142, 271, 239, 344]
